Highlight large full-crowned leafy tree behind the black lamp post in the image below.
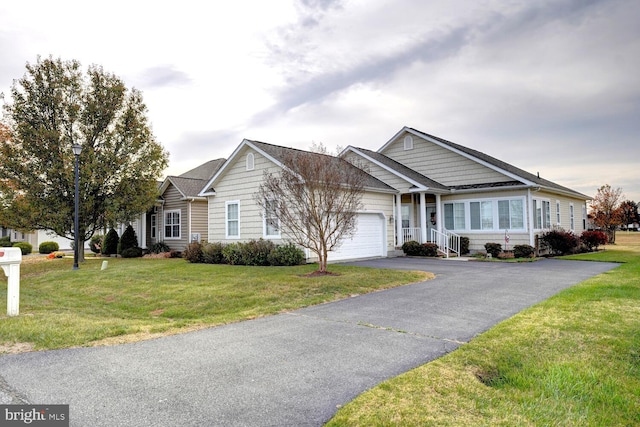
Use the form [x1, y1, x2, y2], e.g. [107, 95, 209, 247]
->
[0, 58, 167, 260]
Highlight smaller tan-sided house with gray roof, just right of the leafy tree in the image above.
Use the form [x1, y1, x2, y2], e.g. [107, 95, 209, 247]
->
[139, 159, 225, 251]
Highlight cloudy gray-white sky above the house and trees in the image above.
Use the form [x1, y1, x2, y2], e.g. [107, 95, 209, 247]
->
[0, 0, 640, 202]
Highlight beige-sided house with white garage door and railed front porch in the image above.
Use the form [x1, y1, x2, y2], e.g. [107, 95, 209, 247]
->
[199, 127, 589, 261]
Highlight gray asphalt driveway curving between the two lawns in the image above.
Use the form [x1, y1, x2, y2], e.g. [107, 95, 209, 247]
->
[0, 258, 617, 427]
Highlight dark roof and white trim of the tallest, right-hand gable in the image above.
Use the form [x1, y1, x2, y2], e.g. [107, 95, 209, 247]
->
[378, 126, 591, 200]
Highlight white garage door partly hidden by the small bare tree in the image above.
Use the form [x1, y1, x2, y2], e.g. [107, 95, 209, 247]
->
[328, 213, 386, 261]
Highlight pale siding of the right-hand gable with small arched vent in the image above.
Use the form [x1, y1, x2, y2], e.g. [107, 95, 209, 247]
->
[382, 133, 513, 186]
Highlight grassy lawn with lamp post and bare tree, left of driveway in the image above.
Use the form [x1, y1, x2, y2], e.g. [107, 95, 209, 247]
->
[0, 258, 427, 353]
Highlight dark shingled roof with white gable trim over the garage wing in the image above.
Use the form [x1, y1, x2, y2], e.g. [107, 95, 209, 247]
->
[199, 139, 395, 196]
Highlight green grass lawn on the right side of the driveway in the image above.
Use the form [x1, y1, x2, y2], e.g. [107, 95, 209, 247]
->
[328, 233, 640, 427]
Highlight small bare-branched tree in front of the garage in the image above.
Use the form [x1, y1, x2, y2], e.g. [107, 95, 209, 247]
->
[254, 145, 369, 273]
